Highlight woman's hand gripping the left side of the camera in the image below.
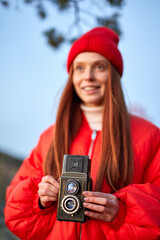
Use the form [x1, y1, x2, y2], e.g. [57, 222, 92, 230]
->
[38, 175, 59, 208]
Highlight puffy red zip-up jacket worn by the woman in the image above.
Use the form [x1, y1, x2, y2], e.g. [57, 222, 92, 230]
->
[5, 117, 160, 240]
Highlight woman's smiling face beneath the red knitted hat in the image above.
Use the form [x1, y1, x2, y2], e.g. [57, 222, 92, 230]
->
[73, 52, 108, 107]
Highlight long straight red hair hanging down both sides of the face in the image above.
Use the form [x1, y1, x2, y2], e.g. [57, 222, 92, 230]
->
[43, 62, 133, 192]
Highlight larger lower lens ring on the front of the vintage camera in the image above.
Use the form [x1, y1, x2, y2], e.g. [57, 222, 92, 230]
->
[61, 196, 80, 214]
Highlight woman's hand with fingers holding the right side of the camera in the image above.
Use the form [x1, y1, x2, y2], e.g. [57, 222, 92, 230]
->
[83, 191, 119, 222]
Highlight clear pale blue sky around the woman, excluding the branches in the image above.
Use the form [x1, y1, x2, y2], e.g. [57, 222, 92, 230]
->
[0, 0, 160, 158]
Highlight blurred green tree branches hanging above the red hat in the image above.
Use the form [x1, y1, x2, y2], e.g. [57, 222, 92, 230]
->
[0, 0, 125, 49]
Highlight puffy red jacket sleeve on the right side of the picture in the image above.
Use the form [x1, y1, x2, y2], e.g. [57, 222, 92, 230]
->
[101, 123, 160, 240]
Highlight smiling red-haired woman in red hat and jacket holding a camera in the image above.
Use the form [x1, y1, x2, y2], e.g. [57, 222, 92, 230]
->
[5, 27, 160, 240]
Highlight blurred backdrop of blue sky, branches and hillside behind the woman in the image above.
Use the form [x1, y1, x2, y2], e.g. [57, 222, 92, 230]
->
[0, 0, 160, 239]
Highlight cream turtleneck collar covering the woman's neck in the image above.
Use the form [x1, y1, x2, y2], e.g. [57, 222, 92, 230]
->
[80, 103, 104, 131]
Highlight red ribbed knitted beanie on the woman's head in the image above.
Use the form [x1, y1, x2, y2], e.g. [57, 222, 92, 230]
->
[67, 27, 123, 76]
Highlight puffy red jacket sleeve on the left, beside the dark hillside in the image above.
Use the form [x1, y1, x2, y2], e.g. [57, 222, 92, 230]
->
[4, 127, 56, 240]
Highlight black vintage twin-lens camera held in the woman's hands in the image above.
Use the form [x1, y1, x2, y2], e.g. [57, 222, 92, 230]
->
[57, 155, 92, 223]
